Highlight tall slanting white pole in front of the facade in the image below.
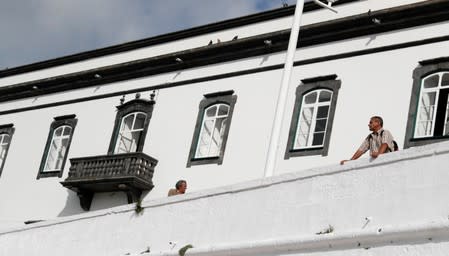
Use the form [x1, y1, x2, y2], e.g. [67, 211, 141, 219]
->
[265, 0, 304, 177]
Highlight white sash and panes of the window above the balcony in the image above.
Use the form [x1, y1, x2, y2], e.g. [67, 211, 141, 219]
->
[115, 112, 147, 154]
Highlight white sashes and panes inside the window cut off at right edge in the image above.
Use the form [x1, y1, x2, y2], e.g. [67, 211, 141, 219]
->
[414, 72, 449, 138]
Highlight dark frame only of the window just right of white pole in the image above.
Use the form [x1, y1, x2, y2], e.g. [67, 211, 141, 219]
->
[284, 74, 341, 159]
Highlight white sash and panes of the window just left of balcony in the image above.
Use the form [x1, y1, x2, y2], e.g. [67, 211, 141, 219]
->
[44, 125, 72, 172]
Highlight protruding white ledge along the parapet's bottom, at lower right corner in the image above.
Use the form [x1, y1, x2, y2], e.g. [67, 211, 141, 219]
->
[145, 221, 449, 256]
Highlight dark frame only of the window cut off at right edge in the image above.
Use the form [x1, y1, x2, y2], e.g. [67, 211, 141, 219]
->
[404, 57, 449, 148]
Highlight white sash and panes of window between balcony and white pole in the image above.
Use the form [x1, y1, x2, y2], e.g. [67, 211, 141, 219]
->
[195, 103, 229, 158]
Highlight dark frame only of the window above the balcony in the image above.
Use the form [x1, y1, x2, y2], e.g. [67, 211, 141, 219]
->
[108, 99, 155, 155]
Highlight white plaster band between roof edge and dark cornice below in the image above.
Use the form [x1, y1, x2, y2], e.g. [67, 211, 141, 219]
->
[0, 0, 423, 86]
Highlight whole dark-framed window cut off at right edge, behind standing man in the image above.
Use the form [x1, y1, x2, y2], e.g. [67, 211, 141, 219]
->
[404, 58, 449, 148]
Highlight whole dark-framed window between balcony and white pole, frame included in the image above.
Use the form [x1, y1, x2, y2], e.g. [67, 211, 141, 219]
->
[187, 91, 237, 167]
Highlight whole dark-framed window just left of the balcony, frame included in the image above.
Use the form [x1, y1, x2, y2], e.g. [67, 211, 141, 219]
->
[37, 115, 78, 179]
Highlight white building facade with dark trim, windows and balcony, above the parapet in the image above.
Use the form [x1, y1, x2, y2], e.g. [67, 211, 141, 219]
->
[0, 0, 449, 254]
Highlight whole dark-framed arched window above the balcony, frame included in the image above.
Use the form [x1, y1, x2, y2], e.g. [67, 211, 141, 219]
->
[108, 98, 154, 154]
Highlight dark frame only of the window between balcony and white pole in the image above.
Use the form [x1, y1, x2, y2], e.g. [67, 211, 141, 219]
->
[187, 90, 237, 167]
